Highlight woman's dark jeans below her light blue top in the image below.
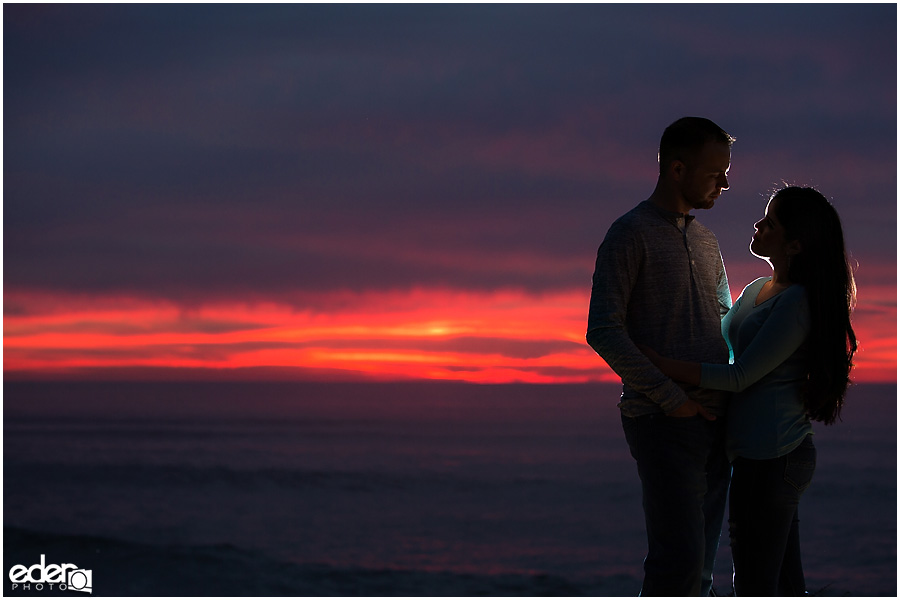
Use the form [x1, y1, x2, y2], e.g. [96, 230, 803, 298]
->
[728, 435, 816, 596]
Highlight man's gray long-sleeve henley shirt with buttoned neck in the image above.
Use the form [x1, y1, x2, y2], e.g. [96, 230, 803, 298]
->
[586, 200, 731, 417]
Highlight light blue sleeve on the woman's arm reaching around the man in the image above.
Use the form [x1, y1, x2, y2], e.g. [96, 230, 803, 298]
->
[700, 285, 811, 392]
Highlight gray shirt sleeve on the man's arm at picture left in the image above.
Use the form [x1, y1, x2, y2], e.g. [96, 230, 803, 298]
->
[586, 223, 688, 412]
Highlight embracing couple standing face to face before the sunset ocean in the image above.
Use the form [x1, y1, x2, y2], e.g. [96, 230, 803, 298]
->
[587, 117, 856, 596]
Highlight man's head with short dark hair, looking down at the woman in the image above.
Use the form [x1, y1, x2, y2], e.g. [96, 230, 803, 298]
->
[659, 117, 734, 212]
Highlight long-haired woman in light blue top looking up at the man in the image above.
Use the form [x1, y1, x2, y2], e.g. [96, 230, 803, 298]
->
[642, 187, 856, 596]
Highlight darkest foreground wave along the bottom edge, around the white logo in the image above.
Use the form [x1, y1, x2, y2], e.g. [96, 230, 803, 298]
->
[3, 528, 640, 597]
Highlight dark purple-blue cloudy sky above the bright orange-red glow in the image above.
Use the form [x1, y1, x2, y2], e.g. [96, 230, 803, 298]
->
[3, 4, 897, 380]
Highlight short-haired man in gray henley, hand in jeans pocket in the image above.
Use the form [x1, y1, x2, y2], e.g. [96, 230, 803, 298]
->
[587, 117, 734, 596]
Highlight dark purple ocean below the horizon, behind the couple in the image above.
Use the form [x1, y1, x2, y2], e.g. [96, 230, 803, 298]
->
[3, 382, 897, 597]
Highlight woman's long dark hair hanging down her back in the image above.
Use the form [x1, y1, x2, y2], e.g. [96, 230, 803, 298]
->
[770, 186, 857, 425]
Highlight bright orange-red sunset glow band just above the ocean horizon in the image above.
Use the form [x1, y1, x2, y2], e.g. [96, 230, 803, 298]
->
[3, 287, 897, 383]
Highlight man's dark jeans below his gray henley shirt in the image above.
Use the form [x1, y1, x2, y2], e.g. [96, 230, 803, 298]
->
[622, 414, 731, 596]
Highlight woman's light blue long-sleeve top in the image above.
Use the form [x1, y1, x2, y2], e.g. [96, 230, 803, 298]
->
[700, 277, 812, 460]
